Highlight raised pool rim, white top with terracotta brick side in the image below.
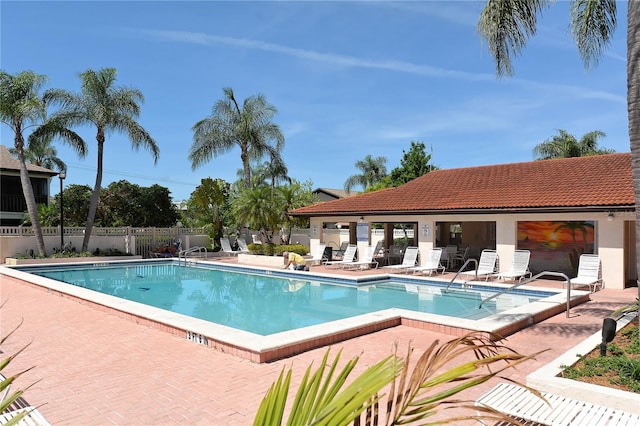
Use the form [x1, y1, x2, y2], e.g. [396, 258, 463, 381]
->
[0, 259, 589, 363]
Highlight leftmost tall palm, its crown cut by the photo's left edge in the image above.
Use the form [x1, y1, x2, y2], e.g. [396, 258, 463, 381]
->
[0, 71, 86, 256]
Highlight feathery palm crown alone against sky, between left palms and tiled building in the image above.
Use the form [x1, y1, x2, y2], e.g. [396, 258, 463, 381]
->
[189, 87, 284, 188]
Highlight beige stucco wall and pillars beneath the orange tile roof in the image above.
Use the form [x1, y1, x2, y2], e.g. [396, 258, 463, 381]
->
[310, 212, 634, 289]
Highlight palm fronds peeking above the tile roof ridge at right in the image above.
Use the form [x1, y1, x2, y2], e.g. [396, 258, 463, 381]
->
[533, 129, 615, 160]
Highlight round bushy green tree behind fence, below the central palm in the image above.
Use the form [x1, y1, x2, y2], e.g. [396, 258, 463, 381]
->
[184, 178, 231, 247]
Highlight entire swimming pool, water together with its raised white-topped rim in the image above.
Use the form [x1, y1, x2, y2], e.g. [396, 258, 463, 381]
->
[2, 260, 588, 362]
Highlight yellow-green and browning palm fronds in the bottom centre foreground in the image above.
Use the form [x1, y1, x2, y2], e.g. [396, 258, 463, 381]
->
[254, 333, 542, 426]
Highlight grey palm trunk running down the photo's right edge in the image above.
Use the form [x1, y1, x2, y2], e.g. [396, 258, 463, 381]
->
[627, 1, 640, 334]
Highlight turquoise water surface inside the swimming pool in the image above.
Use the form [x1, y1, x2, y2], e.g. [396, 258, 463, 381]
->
[22, 263, 544, 335]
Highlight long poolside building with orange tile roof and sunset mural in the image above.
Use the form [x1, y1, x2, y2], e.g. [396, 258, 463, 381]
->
[290, 153, 637, 288]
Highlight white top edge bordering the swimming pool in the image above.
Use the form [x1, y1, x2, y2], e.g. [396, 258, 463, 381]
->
[0, 260, 588, 364]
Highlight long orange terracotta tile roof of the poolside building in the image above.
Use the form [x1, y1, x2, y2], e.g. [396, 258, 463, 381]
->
[291, 153, 635, 216]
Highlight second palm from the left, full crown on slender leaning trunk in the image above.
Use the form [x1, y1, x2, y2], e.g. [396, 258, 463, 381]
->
[45, 68, 160, 251]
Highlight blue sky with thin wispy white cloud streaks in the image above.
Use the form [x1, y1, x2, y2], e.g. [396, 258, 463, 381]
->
[0, 0, 629, 201]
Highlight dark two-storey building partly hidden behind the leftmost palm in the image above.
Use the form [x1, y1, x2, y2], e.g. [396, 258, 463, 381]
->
[0, 145, 58, 226]
